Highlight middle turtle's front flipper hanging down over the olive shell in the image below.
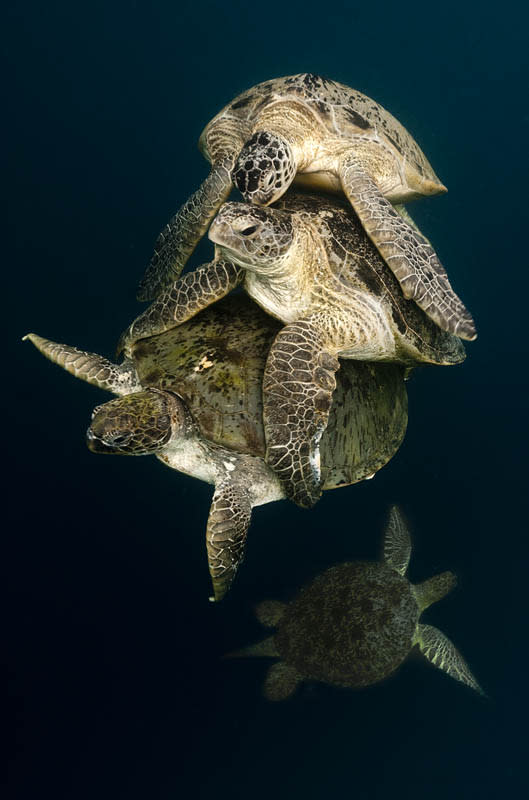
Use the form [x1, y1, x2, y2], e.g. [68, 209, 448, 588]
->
[263, 319, 340, 508]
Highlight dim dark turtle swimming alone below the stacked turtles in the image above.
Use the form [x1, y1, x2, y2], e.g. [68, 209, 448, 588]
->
[229, 506, 482, 700]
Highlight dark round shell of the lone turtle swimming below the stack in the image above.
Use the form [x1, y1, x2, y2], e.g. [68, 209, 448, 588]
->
[275, 561, 419, 687]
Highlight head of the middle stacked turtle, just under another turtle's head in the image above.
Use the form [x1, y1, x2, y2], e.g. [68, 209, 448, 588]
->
[208, 203, 294, 271]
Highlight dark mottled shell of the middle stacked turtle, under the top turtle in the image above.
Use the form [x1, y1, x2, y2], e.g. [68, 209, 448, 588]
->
[276, 192, 465, 364]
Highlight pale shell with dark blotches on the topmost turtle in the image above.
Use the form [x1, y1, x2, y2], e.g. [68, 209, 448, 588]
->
[201, 72, 441, 185]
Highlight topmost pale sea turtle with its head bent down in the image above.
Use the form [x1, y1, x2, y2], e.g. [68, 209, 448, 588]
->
[138, 73, 475, 339]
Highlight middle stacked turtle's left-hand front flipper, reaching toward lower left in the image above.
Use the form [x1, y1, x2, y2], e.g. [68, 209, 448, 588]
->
[117, 260, 244, 354]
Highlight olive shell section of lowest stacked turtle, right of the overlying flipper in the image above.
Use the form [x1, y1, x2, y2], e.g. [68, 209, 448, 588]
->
[320, 359, 408, 489]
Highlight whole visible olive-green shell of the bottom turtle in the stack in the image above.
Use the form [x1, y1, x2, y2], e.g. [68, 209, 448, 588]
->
[133, 294, 408, 488]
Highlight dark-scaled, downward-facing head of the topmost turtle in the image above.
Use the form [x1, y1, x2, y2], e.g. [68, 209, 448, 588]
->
[233, 131, 296, 206]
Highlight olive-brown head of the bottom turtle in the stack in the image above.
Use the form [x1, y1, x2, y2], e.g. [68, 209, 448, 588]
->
[86, 389, 187, 456]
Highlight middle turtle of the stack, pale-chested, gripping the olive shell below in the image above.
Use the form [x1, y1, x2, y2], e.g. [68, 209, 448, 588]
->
[119, 194, 465, 507]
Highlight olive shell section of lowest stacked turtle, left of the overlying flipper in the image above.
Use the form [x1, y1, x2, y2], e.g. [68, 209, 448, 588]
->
[133, 294, 280, 456]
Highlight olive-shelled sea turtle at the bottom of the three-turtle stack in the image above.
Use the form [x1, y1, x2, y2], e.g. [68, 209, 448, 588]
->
[22, 294, 407, 600]
